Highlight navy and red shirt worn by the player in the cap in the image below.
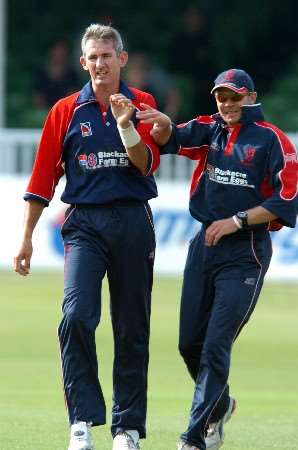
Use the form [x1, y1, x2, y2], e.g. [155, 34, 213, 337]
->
[161, 104, 298, 229]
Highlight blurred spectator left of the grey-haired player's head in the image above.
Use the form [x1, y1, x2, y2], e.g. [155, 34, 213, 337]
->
[33, 39, 80, 111]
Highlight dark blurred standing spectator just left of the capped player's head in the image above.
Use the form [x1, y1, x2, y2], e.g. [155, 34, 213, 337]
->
[168, 5, 214, 118]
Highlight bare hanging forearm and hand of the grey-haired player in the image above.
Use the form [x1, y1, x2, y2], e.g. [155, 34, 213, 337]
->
[13, 200, 45, 276]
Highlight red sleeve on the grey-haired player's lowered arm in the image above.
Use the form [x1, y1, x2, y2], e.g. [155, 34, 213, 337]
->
[27, 92, 79, 201]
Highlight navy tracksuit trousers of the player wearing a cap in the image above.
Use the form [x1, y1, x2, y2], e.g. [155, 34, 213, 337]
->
[179, 227, 272, 450]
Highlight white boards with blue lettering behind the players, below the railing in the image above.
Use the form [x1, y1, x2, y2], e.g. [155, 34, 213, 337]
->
[0, 175, 298, 282]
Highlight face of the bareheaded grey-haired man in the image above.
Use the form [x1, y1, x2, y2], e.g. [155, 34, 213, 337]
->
[80, 39, 127, 91]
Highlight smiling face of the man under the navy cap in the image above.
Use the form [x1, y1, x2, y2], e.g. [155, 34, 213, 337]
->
[214, 88, 257, 126]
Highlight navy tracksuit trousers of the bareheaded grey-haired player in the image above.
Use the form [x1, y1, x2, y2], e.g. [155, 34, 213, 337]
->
[58, 202, 155, 437]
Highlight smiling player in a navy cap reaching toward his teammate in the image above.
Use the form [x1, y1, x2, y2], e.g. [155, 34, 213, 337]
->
[137, 69, 298, 450]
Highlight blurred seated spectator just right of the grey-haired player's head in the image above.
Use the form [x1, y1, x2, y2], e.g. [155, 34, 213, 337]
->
[124, 52, 180, 120]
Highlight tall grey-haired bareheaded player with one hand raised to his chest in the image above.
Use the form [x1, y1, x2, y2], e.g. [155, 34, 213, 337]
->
[14, 24, 159, 450]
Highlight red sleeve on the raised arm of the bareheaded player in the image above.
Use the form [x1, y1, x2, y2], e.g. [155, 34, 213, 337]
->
[129, 87, 160, 176]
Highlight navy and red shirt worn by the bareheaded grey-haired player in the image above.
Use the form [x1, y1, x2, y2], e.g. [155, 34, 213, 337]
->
[24, 82, 159, 205]
